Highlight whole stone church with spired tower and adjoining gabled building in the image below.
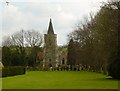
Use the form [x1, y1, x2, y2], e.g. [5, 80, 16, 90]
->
[42, 19, 67, 68]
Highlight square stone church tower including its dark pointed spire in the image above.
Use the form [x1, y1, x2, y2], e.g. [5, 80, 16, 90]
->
[43, 19, 57, 68]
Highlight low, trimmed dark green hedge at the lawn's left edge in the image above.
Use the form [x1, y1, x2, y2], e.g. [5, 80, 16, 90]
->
[2, 66, 25, 77]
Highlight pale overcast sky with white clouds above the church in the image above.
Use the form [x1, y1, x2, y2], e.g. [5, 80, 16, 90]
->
[0, 0, 107, 45]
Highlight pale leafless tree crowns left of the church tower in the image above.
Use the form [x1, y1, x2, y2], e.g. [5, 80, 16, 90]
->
[2, 30, 43, 47]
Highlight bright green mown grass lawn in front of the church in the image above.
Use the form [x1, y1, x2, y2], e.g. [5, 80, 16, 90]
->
[2, 71, 118, 89]
